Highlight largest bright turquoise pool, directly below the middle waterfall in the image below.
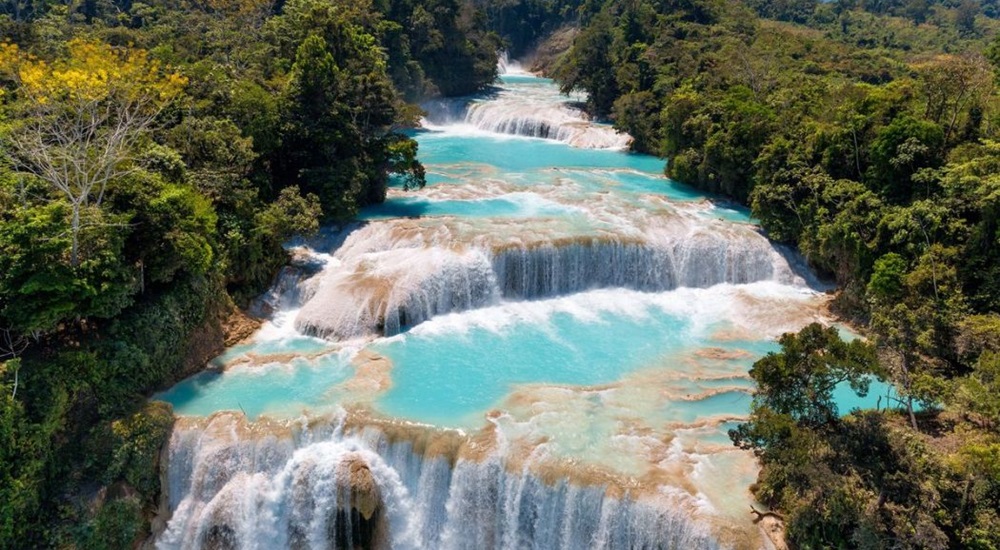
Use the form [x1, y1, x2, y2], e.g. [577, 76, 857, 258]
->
[374, 296, 691, 426]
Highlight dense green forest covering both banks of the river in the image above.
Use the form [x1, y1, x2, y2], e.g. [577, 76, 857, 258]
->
[0, 0, 1000, 549]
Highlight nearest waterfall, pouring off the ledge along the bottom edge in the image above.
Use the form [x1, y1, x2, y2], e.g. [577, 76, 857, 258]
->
[157, 414, 718, 550]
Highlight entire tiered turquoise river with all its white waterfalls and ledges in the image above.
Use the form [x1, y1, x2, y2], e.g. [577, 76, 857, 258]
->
[155, 62, 877, 549]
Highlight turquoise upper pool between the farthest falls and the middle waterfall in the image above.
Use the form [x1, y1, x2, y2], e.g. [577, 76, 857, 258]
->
[374, 131, 750, 223]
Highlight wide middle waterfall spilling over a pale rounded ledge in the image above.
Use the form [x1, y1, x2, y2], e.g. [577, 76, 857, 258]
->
[295, 218, 802, 339]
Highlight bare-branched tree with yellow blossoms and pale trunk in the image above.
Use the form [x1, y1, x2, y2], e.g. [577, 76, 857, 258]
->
[0, 39, 187, 265]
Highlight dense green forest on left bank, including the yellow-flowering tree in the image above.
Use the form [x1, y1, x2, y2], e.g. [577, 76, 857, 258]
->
[0, 0, 499, 548]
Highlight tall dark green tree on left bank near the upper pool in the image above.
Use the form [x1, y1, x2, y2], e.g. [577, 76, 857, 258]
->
[274, 30, 413, 219]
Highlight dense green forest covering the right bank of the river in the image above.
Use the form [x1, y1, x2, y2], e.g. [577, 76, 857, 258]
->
[550, 0, 1000, 548]
